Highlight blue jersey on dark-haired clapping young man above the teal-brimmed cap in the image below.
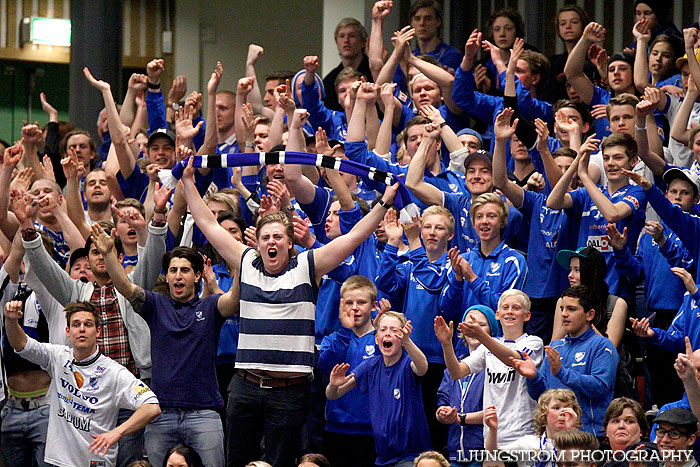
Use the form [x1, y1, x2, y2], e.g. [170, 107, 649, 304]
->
[566, 183, 647, 298]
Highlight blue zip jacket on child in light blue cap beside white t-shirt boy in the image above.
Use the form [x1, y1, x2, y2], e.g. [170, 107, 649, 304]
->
[438, 370, 486, 462]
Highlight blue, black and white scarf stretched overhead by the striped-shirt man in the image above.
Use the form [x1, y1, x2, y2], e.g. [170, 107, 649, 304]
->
[158, 151, 419, 223]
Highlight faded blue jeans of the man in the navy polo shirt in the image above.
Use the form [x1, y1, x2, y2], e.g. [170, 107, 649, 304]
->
[146, 407, 224, 467]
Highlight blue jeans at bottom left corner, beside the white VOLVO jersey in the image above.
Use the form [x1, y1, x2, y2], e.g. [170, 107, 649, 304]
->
[0, 405, 51, 467]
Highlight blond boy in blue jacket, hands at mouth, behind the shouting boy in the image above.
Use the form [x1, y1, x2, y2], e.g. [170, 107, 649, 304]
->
[318, 276, 379, 466]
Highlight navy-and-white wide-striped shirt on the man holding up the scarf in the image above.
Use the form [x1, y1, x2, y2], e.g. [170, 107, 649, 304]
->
[236, 248, 318, 373]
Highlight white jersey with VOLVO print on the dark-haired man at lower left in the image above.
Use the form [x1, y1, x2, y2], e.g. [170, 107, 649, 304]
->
[18, 338, 158, 467]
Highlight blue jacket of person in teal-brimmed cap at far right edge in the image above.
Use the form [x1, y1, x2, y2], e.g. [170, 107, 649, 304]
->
[613, 221, 694, 310]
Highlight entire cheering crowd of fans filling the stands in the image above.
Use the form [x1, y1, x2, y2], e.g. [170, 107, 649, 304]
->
[0, 0, 700, 467]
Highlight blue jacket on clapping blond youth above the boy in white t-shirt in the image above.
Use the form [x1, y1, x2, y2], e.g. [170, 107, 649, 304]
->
[440, 241, 527, 314]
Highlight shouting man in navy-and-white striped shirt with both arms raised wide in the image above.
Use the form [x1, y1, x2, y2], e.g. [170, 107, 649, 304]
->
[182, 160, 398, 467]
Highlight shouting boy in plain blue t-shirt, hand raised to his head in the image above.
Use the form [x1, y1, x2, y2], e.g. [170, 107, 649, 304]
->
[326, 311, 431, 467]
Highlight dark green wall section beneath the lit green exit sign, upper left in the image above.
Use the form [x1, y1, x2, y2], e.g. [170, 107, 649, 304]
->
[0, 60, 69, 143]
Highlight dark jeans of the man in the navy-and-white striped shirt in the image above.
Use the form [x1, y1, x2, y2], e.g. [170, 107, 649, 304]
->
[226, 374, 309, 467]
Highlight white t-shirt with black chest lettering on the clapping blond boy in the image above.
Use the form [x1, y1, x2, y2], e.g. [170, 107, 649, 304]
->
[463, 334, 544, 446]
